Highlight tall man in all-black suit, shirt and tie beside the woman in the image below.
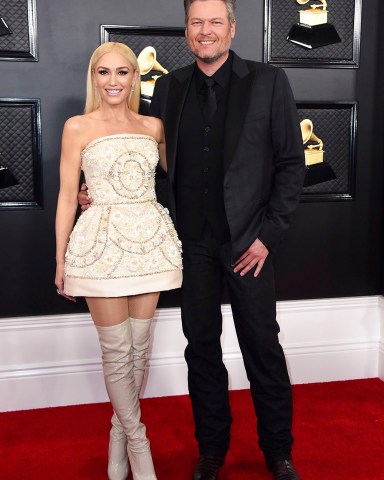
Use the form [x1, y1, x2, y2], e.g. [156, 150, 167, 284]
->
[150, 0, 304, 480]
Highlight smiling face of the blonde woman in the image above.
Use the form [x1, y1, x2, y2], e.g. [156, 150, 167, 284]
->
[93, 51, 137, 105]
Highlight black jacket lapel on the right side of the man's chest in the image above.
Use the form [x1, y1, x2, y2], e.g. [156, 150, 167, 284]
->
[224, 53, 253, 175]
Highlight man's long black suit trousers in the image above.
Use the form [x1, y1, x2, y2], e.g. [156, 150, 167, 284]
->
[178, 227, 292, 460]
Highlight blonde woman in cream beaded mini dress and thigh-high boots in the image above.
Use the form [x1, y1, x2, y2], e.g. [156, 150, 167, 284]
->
[55, 42, 182, 480]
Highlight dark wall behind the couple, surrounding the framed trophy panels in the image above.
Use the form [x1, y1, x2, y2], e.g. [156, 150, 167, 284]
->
[0, 0, 384, 317]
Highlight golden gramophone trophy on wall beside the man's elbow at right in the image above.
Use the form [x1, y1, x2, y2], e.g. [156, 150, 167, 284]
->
[300, 118, 336, 187]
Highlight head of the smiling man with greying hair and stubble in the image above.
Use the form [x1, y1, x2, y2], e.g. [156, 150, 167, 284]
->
[185, 0, 236, 63]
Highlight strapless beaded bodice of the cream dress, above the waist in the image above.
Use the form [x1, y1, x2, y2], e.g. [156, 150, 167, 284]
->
[81, 134, 159, 205]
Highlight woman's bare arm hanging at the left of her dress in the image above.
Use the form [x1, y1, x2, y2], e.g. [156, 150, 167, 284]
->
[55, 117, 81, 301]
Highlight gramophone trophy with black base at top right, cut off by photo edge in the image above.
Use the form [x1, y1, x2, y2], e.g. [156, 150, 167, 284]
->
[287, 0, 341, 48]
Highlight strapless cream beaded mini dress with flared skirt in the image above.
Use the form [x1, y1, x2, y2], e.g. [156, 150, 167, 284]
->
[64, 134, 182, 297]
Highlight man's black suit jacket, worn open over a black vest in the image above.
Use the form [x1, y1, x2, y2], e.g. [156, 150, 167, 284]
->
[150, 54, 305, 259]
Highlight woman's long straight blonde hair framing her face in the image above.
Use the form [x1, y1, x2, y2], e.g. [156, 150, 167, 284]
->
[84, 42, 140, 113]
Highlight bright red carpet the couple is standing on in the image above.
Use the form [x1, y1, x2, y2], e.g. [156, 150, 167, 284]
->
[0, 379, 384, 480]
